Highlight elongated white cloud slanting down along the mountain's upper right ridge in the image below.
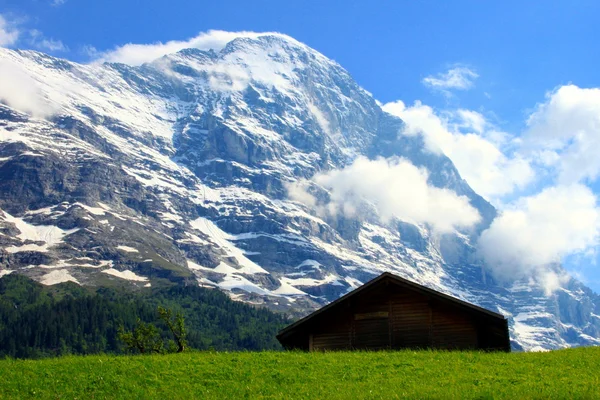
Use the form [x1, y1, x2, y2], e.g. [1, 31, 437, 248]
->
[383, 101, 535, 200]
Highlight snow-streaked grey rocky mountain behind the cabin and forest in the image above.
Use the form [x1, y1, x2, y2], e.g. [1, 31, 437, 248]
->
[0, 35, 600, 350]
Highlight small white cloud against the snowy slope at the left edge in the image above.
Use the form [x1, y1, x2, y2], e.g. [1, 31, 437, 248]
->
[0, 59, 55, 118]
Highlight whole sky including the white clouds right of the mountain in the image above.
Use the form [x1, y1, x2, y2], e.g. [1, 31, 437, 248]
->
[0, 0, 600, 291]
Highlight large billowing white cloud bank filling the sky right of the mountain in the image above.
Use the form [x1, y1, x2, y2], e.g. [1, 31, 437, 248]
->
[383, 85, 600, 295]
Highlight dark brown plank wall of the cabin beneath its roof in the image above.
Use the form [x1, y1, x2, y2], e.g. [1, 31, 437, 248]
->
[303, 285, 506, 351]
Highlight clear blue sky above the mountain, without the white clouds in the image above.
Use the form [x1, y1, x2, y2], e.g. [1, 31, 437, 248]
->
[0, 0, 600, 120]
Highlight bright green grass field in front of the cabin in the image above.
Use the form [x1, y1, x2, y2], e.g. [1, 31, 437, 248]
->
[0, 348, 600, 400]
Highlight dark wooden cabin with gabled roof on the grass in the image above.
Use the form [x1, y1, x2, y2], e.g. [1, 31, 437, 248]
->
[277, 272, 510, 351]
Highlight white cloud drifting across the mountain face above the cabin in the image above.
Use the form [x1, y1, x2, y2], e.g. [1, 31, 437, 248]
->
[288, 157, 480, 232]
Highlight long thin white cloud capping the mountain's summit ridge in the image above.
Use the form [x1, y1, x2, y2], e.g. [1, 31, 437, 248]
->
[95, 30, 293, 65]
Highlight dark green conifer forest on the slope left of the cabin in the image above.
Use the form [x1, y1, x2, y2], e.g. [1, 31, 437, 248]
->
[0, 274, 288, 358]
